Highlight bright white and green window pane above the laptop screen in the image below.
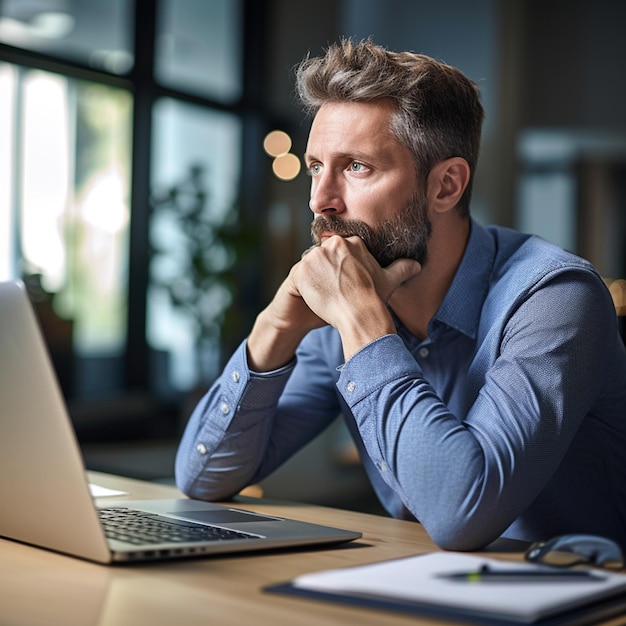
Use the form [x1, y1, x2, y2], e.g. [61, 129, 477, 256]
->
[0, 64, 132, 355]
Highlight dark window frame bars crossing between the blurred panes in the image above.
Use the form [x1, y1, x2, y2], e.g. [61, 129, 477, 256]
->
[0, 0, 271, 391]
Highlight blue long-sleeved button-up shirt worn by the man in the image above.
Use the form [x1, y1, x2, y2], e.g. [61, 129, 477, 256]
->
[176, 221, 626, 550]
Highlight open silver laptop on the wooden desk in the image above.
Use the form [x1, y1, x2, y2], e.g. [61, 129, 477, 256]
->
[0, 281, 361, 563]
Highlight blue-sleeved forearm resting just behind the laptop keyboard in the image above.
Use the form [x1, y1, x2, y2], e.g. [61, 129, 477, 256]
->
[176, 329, 341, 500]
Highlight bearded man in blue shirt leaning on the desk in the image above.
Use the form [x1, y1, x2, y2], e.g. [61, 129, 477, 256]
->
[176, 40, 626, 550]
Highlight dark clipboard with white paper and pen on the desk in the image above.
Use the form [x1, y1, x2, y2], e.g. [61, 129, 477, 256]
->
[266, 552, 626, 626]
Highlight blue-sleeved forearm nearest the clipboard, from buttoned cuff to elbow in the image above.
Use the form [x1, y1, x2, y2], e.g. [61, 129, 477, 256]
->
[339, 336, 494, 549]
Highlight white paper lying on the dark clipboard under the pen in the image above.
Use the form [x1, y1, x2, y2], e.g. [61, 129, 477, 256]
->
[293, 552, 626, 622]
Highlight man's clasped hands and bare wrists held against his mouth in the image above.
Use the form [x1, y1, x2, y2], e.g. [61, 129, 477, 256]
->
[248, 235, 421, 371]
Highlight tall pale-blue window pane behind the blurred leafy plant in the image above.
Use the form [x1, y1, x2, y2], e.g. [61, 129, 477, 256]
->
[148, 99, 241, 390]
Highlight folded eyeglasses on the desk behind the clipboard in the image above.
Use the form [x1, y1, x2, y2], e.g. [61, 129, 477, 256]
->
[526, 534, 624, 569]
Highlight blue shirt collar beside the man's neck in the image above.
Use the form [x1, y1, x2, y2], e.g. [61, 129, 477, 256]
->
[428, 219, 496, 339]
